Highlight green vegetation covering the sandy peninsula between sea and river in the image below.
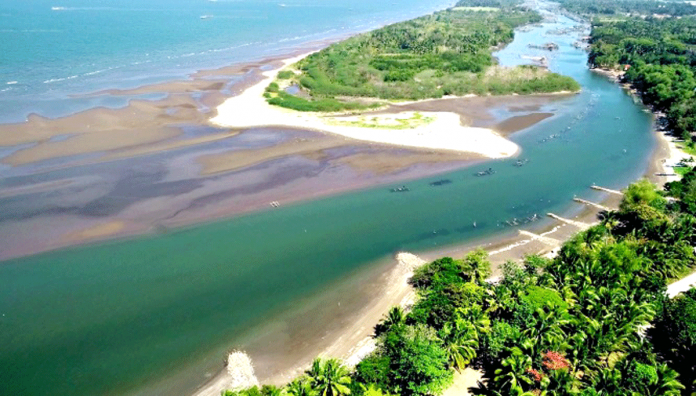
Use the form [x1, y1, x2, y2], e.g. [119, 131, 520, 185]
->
[268, 0, 580, 111]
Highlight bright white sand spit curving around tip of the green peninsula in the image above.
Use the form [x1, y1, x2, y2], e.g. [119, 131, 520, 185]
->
[210, 54, 519, 158]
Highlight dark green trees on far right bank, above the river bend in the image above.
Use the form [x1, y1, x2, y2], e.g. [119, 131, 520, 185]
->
[589, 17, 696, 146]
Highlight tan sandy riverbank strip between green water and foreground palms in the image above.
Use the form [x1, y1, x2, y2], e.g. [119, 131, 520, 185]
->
[193, 179, 620, 396]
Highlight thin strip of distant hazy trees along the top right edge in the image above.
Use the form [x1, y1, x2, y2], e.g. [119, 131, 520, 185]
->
[560, 0, 696, 16]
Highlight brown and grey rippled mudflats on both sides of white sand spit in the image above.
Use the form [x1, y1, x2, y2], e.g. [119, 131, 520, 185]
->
[0, 84, 569, 260]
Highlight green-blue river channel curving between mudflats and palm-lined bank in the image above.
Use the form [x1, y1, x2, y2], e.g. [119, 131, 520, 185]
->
[0, 7, 654, 395]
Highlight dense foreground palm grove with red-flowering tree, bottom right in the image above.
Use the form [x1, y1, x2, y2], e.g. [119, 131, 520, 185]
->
[227, 168, 696, 396]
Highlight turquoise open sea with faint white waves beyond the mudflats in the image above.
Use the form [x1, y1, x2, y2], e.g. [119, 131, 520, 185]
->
[0, 0, 453, 123]
